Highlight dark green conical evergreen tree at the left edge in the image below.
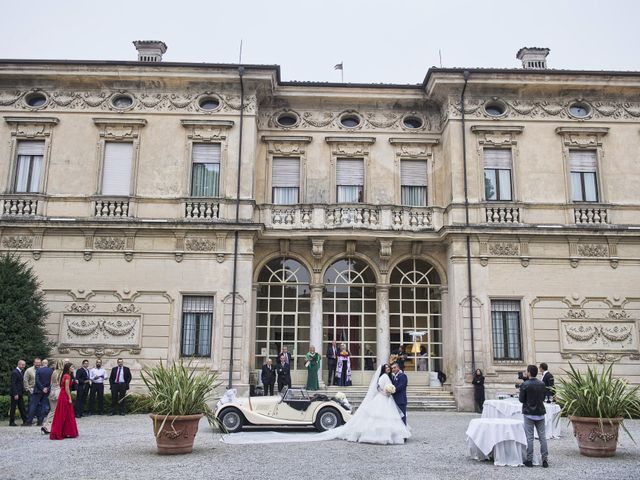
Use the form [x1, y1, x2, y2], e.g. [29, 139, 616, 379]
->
[0, 254, 53, 394]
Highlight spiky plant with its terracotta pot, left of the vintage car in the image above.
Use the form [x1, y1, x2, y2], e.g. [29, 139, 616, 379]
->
[141, 360, 221, 455]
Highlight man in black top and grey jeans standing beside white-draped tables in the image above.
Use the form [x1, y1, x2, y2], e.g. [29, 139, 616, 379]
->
[520, 365, 549, 468]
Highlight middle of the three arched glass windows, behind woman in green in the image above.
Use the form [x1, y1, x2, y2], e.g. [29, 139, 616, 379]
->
[322, 258, 376, 371]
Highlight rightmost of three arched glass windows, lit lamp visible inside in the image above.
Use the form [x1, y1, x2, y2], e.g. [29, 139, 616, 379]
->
[389, 259, 443, 371]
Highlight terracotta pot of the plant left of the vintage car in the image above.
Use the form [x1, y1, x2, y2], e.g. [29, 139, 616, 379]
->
[149, 413, 203, 455]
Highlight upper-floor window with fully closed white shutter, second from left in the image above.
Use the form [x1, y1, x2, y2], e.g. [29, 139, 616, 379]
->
[102, 142, 133, 197]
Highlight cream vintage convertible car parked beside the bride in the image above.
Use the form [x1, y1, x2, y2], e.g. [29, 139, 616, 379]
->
[215, 388, 351, 433]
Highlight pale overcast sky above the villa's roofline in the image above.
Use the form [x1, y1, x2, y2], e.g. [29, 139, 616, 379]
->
[0, 0, 640, 84]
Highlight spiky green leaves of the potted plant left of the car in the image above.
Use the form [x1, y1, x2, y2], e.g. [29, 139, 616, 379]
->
[140, 359, 222, 435]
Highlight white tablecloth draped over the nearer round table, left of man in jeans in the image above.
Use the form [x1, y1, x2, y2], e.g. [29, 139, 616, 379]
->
[466, 418, 527, 467]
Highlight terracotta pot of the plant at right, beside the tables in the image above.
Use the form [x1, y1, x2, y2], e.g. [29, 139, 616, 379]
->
[569, 417, 623, 457]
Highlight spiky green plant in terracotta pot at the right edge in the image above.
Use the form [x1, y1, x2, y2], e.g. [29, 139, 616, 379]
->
[555, 364, 640, 457]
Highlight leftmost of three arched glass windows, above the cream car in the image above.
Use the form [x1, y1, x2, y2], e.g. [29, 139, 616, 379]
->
[254, 257, 310, 370]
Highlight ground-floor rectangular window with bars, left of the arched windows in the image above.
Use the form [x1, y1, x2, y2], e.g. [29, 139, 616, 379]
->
[180, 296, 213, 357]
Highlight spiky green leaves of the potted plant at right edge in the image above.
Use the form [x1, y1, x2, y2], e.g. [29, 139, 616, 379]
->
[555, 363, 640, 439]
